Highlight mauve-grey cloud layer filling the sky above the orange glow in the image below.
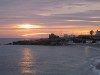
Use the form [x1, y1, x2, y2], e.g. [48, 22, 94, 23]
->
[0, 0, 100, 26]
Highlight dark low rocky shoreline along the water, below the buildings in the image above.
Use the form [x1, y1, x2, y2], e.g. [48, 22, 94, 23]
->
[6, 38, 100, 48]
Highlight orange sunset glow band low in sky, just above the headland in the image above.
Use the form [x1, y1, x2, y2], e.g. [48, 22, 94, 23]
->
[0, 24, 99, 38]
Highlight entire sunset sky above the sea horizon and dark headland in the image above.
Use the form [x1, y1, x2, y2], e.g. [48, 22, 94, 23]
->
[0, 0, 100, 38]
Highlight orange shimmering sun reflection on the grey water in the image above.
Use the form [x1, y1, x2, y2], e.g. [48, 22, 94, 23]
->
[20, 48, 36, 75]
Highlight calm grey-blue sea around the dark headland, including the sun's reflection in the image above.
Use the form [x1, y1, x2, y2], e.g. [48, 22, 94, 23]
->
[0, 38, 100, 75]
